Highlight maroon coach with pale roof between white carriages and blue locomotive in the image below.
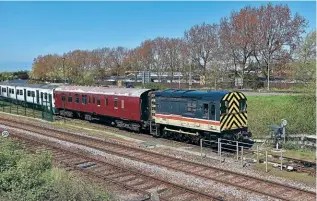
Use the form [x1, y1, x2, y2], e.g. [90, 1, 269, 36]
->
[54, 86, 151, 131]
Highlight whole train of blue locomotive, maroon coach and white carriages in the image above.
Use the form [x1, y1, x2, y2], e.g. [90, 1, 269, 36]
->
[0, 83, 251, 143]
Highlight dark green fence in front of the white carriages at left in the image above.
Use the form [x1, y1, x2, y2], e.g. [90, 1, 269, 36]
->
[0, 94, 54, 121]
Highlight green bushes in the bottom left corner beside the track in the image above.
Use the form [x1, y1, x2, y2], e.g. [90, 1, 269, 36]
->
[0, 138, 111, 201]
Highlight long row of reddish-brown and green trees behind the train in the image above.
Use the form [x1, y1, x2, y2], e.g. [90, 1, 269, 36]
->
[31, 3, 316, 84]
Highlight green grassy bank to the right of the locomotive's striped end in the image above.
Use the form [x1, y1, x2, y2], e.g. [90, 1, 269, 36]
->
[247, 95, 316, 137]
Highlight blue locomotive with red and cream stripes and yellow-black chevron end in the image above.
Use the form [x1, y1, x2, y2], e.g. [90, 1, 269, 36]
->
[153, 90, 250, 141]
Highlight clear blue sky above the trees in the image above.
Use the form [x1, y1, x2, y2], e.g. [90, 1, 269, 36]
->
[0, 1, 316, 72]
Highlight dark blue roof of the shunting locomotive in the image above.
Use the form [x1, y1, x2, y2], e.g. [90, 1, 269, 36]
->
[155, 89, 230, 102]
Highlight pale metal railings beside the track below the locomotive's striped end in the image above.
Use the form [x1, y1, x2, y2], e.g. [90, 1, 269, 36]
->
[200, 138, 314, 172]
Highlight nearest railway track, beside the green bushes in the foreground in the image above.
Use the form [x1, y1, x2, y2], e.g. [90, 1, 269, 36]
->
[10, 133, 223, 201]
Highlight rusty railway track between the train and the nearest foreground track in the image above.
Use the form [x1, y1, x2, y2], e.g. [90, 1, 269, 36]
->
[0, 118, 316, 201]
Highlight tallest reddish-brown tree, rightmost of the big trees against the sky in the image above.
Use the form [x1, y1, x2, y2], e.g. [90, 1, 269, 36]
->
[254, 4, 307, 76]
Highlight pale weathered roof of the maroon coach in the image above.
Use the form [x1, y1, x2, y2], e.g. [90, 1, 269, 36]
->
[55, 86, 151, 97]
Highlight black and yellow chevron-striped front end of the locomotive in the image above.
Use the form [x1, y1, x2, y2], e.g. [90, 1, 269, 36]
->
[220, 92, 247, 130]
